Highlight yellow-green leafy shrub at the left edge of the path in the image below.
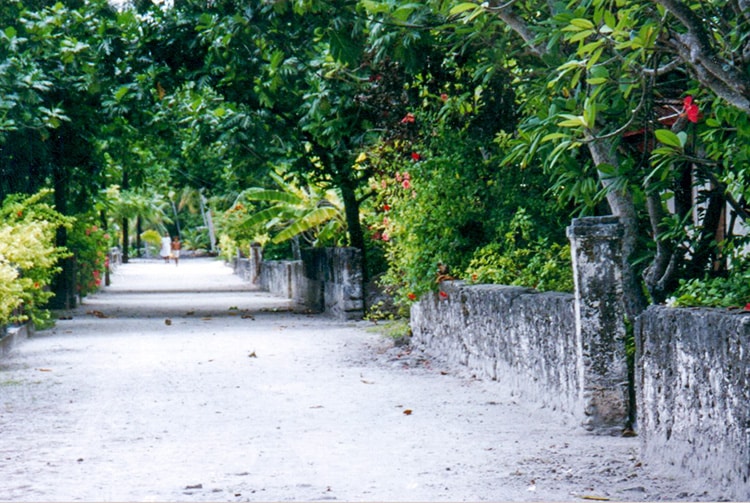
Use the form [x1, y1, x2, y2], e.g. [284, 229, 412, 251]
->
[0, 190, 72, 325]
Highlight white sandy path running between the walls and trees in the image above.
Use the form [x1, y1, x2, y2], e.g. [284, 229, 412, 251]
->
[0, 259, 721, 501]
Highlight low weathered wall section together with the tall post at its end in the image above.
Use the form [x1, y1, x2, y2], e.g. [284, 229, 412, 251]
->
[411, 217, 631, 434]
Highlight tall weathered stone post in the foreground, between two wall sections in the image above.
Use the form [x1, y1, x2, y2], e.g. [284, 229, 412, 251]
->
[567, 216, 629, 434]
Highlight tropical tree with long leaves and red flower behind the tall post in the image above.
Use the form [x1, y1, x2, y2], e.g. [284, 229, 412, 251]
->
[440, 0, 750, 316]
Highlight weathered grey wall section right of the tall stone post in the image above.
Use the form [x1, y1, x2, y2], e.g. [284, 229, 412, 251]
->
[635, 306, 750, 501]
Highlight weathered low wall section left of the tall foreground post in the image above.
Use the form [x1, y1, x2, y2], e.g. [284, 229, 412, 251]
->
[411, 281, 584, 421]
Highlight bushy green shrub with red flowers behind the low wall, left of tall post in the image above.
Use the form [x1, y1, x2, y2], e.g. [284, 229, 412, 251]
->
[370, 126, 570, 303]
